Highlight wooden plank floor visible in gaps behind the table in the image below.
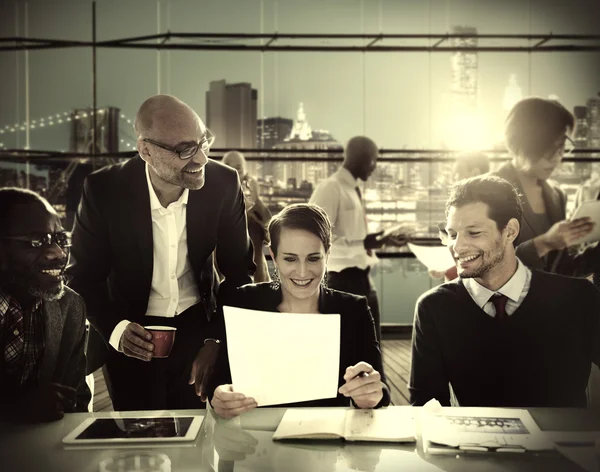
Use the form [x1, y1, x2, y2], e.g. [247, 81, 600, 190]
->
[94, 339, 410, 411]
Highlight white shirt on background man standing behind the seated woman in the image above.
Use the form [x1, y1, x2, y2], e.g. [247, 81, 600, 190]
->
[310, 167, 378, 272]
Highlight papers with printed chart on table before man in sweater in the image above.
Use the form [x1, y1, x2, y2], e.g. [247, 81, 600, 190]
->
[421, 408, 555, 453]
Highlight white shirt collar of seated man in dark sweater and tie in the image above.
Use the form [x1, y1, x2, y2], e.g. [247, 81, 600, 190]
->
[462, 259, 531, 317]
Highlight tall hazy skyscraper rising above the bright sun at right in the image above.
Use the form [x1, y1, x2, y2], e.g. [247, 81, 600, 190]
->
[450, 26, 478, 111]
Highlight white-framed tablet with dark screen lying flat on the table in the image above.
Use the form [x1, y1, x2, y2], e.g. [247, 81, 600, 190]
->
[63, 416, 204, 445]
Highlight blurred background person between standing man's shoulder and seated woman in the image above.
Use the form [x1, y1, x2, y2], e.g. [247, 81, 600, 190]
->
[223, 151, 271, 283]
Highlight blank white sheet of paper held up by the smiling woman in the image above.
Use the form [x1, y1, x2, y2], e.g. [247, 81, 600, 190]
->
[223, 306, 340, 406]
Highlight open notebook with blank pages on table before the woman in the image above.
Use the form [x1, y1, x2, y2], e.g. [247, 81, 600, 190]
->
[273, 406, 416, 442]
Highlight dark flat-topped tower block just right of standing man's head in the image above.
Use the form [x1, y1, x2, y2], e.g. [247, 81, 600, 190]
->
[206, 80, 258, 149]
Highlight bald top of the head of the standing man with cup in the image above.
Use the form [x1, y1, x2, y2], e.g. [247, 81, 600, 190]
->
[133, 95, 204, 139]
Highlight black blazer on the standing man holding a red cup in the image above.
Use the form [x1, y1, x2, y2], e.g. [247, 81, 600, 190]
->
[67, 156, 255, 341]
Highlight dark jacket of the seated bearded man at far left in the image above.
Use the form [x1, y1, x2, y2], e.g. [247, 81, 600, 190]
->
[0, 288, 91, 411]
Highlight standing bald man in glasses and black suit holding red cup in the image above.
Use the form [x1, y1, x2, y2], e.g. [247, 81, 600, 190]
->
[68, 95, 255, 410]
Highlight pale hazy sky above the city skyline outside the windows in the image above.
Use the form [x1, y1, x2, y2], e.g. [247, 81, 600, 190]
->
[0, 0, 600, 150]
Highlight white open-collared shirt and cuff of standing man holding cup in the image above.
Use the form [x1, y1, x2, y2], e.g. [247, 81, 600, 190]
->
[109, 164, 200, 349]
